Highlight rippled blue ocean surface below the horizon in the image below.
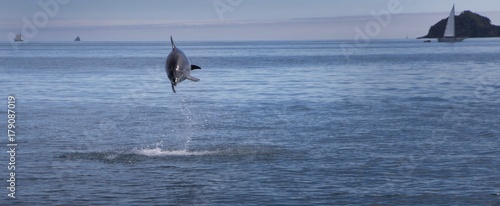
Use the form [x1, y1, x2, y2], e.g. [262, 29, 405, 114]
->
[0, 37, 500, 205]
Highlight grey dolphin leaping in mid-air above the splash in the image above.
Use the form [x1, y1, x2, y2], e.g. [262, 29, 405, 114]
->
[165, 36, 201, 93]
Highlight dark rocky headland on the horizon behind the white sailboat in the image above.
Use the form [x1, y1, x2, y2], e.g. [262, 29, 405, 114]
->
[417, 11, 500, 39]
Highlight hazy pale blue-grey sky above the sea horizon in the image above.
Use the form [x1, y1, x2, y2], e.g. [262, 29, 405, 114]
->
[0, 0, 500, 41]
